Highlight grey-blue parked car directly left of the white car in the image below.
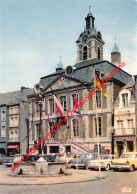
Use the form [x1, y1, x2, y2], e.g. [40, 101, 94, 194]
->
[68, 154, 97, 168]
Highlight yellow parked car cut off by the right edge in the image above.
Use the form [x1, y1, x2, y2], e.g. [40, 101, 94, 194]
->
[110, 152, 137, 172]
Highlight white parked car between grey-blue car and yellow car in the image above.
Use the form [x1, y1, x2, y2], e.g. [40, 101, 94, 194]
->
[86, 155, 118, 170]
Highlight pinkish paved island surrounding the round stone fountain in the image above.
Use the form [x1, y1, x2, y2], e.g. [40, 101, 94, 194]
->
[0, 167, 108, 185]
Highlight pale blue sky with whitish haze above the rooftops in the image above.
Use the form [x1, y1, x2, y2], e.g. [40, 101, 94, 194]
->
[0, 0, 137, 93]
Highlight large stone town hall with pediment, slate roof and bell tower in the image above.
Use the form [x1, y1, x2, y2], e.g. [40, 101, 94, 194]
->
[28, 13, 132, 154]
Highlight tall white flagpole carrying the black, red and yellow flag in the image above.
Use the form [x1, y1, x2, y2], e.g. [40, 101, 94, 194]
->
[94, 69, 101, 179]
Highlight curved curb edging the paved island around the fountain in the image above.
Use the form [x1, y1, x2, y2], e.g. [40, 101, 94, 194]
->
[0, 175, 108, 186]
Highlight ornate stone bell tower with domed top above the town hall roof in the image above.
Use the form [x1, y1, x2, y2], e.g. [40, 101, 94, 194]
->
[76, 12, 105, 63]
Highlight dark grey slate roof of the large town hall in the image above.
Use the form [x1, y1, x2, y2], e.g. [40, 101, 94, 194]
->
[39, 59, 133, 88]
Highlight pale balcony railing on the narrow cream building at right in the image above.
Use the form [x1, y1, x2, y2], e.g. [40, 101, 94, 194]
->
[115, 128, 135, 135]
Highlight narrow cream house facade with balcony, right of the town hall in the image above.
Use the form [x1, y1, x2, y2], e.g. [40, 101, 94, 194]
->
[114, 83, 137, 156]
